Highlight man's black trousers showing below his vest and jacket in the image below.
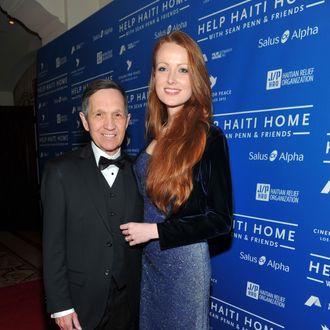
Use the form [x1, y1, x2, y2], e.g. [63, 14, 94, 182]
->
[95, 279, 139, 330]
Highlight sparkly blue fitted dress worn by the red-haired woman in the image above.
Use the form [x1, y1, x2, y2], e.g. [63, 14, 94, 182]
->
[134, 152, 211, 330]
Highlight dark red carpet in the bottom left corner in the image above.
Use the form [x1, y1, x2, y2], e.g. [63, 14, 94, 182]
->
[0, 280, 59, 330]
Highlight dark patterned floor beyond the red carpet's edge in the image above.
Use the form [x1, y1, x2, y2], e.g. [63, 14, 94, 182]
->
[0, 231, 42, 288]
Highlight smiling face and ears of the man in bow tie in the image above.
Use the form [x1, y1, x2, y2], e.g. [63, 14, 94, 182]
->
[79, 89, 130, 155]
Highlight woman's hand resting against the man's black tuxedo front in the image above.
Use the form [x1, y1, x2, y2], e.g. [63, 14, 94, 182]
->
[120, 222, 159, 246]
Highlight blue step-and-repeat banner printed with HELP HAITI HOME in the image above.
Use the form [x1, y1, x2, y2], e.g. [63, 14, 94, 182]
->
[37, 0, 330, 330]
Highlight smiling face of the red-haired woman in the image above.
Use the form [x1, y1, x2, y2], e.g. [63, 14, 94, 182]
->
[154, 42, 192, 116]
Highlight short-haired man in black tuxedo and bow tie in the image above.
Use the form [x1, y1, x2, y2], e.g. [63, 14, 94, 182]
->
[41, 80, 142, 330]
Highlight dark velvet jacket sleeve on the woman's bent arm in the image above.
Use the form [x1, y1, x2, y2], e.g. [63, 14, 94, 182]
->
[157, 127, 233, 249]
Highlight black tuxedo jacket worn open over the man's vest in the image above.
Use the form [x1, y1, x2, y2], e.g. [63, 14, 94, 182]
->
[41, 144, 143, 329]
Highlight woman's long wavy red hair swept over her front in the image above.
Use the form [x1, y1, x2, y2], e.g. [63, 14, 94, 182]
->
[146, 31, 212, 213]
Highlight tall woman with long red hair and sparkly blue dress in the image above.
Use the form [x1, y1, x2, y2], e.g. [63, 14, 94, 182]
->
[120, 31, 232, 330]
